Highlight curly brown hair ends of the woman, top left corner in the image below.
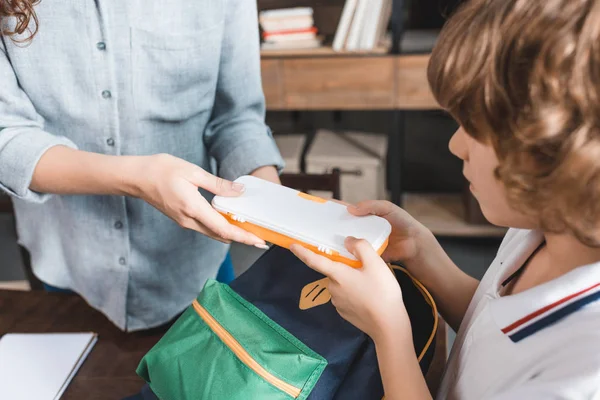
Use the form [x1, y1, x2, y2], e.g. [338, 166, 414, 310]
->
[0, 0, 40, 43]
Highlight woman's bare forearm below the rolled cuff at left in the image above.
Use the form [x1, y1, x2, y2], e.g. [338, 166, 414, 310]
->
[30, 146, 142, 195]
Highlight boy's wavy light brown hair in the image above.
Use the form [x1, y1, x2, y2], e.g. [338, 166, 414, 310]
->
[428, 0, 600, 246]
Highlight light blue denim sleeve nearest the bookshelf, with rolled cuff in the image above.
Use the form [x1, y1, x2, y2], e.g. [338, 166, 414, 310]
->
[204, 0, 283, 179]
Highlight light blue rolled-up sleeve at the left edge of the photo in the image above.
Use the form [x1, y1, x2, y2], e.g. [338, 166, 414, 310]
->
[0, 38, 77, 203]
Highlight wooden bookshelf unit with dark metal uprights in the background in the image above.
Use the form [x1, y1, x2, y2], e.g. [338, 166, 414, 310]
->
[258, 0, 496, 238]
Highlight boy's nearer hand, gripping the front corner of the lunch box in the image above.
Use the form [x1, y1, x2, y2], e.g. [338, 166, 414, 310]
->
[291, 238, 411, 341]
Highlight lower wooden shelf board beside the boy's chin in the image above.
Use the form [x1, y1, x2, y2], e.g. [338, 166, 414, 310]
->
[403, 193, 506, 238]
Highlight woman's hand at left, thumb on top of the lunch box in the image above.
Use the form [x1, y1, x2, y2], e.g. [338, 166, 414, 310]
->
[132, 154, 266, 248]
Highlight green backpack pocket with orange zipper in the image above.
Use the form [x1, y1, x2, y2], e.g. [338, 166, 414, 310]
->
[137, 280, 327, 400]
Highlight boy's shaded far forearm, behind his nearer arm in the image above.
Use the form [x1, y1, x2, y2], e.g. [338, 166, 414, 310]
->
[406, 228, 479, 331]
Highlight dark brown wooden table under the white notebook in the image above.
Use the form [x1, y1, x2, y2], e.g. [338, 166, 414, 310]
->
[0, 291, 167, 400]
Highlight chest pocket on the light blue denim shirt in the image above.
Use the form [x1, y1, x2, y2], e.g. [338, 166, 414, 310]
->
[131, 26, 222, 122]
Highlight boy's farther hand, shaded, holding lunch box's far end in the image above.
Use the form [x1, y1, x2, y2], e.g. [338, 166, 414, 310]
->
[348, 200, 431, 264]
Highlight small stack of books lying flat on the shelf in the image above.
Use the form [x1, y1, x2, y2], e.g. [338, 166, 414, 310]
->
[259, 7, 322, 50]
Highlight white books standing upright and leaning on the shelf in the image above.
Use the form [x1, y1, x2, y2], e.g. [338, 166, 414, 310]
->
[333, 0, 392, 51]
